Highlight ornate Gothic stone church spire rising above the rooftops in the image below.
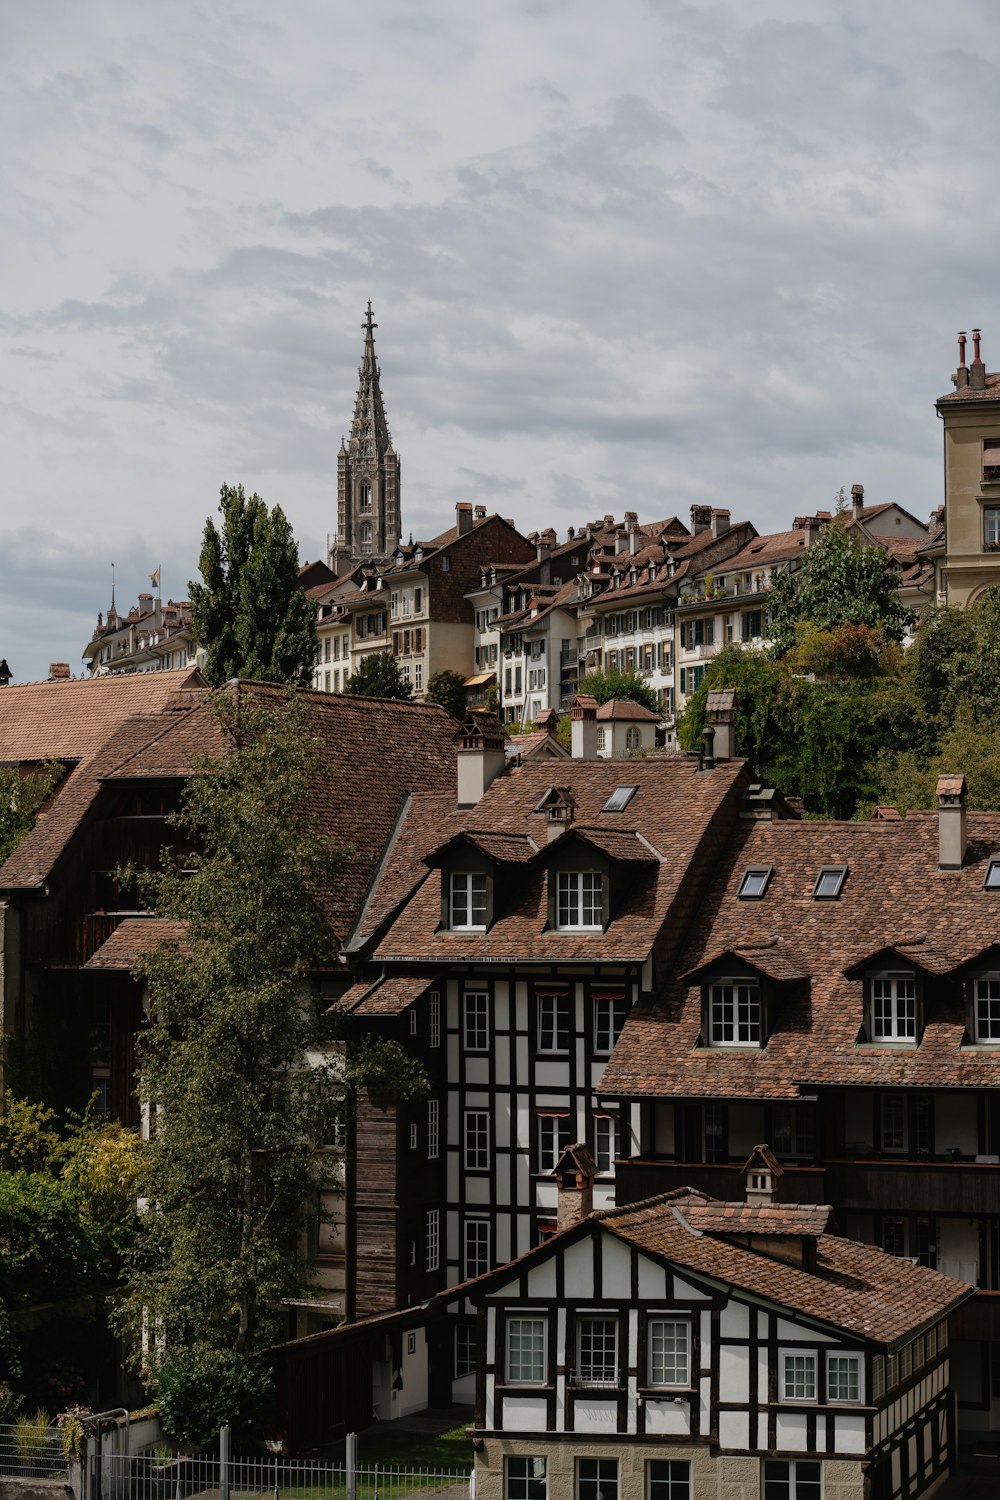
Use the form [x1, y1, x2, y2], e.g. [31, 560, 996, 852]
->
[330, 302, 400, 572]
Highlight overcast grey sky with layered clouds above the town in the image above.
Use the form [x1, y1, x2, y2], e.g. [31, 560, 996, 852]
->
[0, 0, 1000, 681]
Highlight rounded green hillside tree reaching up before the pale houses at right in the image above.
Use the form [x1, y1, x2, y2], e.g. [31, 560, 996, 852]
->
[768, 516, 915, 656]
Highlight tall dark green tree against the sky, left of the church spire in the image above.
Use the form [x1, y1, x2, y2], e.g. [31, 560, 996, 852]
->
[189, 485, 318, 687]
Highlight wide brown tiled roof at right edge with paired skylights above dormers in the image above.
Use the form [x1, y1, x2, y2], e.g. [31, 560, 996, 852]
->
[601, 813, 1000, 1100]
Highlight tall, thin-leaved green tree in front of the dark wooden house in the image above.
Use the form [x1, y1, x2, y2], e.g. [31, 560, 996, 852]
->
[118, 690, 421, 1365]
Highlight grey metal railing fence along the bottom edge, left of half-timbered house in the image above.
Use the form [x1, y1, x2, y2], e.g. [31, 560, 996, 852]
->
[87, 1454, 469, 1500]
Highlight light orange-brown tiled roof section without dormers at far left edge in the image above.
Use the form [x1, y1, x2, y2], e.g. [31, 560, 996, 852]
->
[0, 668, 205, 764]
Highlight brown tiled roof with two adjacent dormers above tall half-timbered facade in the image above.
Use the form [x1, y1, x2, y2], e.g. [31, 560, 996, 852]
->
[373, 756, 748, 963]
